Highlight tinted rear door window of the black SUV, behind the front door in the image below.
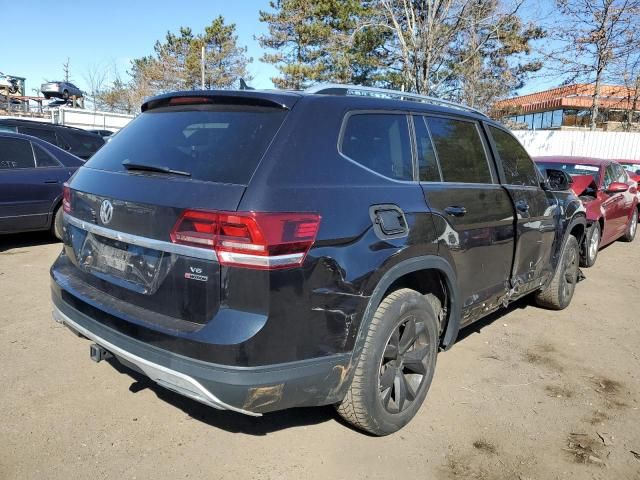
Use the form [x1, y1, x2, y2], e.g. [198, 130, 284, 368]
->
[427, 117, 493, 183]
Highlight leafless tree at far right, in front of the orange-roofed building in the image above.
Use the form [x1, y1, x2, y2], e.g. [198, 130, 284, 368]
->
[549, 0, 640, 130]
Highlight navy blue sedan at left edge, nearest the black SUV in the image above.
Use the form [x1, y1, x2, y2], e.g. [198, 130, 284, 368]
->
[0, 131, 83, 239]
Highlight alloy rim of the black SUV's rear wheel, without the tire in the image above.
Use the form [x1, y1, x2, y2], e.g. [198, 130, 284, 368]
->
[378, 316, 430, 413]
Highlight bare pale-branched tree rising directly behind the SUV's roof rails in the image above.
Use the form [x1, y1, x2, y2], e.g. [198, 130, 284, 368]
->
[361, 0, 544, 103]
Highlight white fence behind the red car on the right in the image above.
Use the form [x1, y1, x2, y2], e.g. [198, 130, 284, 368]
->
[513, 130, 640, 160]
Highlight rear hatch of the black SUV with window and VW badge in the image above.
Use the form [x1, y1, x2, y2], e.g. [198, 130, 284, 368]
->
[62, 96, 287, 330]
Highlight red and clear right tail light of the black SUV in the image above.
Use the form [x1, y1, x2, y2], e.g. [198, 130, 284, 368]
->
[171, 210, 320, 270]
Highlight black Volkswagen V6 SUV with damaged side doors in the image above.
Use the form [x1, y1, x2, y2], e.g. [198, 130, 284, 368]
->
[51, 86, 585, 435]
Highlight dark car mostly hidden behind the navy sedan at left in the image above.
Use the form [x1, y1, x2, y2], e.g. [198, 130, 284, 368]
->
[0, 118, 104, 160]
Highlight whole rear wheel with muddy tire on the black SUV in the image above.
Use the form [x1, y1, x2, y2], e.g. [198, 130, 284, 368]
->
[337, 288, 439, 436]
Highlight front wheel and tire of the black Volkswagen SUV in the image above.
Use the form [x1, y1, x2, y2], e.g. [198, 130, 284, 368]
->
[535, 235, 580, 310]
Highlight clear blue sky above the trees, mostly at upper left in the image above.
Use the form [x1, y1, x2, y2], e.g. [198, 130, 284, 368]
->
[0, 0, 557, 95]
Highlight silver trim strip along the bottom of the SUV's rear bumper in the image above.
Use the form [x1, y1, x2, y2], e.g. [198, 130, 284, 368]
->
[53, 305, 262, 417]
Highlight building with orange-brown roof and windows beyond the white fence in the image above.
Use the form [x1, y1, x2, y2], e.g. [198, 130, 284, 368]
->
[495, 84, 640, 130]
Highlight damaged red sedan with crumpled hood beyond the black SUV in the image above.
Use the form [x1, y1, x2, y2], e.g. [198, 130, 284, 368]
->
[534, 157, 639, 267]
